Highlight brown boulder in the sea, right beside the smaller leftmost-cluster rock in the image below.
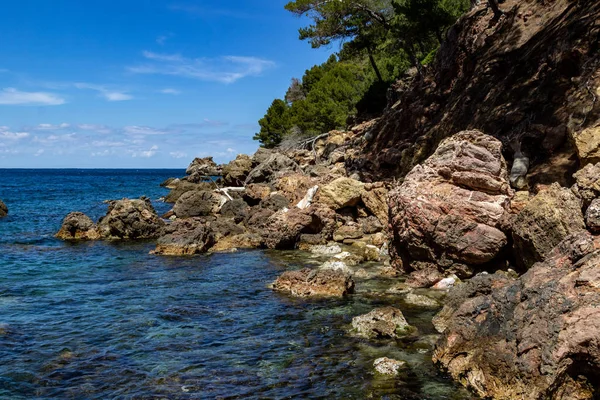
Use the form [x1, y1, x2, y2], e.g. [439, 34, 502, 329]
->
[98, 197, 165, 240]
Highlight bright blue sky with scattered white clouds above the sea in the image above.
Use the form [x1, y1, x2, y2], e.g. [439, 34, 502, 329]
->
[0, 0, 337, 168]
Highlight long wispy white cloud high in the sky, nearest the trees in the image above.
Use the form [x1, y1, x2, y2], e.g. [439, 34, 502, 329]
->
[129, 51, 275, 83]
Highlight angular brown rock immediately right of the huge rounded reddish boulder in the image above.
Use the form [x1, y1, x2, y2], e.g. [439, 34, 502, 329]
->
[512, 183, 585, 268]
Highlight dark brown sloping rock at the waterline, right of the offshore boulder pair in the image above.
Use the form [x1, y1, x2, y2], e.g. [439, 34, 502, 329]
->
[153, 218, 215, 256]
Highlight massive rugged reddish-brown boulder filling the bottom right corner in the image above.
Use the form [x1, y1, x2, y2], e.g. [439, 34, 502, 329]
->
[433, 231, 600, 400]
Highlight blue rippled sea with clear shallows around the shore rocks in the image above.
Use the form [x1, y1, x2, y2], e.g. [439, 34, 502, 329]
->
[0, 170, 471, 400]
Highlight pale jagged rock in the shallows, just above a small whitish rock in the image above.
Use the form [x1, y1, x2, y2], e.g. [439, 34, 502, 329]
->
[352, 307, 411, 339]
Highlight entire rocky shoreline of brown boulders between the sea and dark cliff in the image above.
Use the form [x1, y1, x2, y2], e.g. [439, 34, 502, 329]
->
[51, 124, 600, 399]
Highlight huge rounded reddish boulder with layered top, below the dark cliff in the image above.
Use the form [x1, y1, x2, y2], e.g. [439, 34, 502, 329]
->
[389, 131, 512, 271]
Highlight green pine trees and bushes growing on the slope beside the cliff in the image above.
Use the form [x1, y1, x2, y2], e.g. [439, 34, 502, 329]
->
[254, 0, 470, 147]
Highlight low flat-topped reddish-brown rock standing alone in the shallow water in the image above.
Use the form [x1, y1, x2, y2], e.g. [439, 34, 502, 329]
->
[272, 268, 354, 297]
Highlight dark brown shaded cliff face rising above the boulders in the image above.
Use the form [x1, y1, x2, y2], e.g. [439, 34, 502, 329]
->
[352, 0, 600, 186]
